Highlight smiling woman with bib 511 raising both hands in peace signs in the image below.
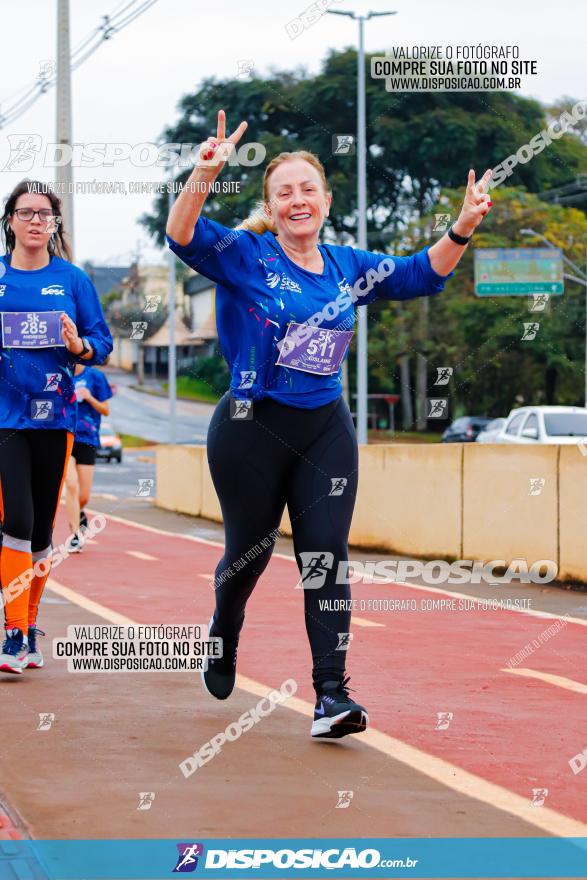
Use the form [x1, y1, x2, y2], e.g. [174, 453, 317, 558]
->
[167, 110, 491, 737]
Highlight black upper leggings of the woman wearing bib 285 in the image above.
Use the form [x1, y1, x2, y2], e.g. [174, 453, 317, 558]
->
[0, 428, 72, 553]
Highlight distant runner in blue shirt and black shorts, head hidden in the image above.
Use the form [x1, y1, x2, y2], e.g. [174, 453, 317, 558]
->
[65, 364, 112, 553]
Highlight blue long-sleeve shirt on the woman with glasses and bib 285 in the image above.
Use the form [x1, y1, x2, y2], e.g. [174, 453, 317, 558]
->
[0, 255, 112, 432]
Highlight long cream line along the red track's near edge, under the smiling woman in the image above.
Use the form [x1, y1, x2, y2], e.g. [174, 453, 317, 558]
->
[47, 578, 587, 837]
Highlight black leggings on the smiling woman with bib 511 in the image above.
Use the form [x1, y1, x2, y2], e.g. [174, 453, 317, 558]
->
[207, 392, 358, 684]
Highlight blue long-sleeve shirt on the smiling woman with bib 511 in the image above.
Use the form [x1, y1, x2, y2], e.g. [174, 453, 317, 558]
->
[167, 217, 452, 409]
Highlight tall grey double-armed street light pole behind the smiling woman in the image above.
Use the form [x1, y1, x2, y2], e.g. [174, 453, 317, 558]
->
[328, 9, 397, 444]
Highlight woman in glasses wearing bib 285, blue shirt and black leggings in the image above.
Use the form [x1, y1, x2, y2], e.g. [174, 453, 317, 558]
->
[0, 181, 112, 674]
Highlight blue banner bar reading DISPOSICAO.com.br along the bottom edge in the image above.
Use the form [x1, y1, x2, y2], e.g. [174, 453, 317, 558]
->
[0, 837, 587, 880]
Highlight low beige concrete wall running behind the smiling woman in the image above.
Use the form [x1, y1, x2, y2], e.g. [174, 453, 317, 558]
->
[157, 443, 587, 582]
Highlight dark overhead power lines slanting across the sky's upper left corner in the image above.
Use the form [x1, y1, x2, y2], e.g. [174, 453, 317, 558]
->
[0, 0, 159, 129]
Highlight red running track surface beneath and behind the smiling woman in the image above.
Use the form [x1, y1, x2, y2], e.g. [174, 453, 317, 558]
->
[53, 509, 587, 822]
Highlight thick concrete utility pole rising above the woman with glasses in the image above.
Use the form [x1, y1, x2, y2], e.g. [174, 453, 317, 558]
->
[55, 0, 74, 254]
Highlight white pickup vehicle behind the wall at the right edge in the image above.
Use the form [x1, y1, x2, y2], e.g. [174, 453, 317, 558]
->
[495, 406, 587, 446]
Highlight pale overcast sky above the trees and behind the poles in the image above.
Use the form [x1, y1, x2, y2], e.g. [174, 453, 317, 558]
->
[0, 0, 587, 263]
